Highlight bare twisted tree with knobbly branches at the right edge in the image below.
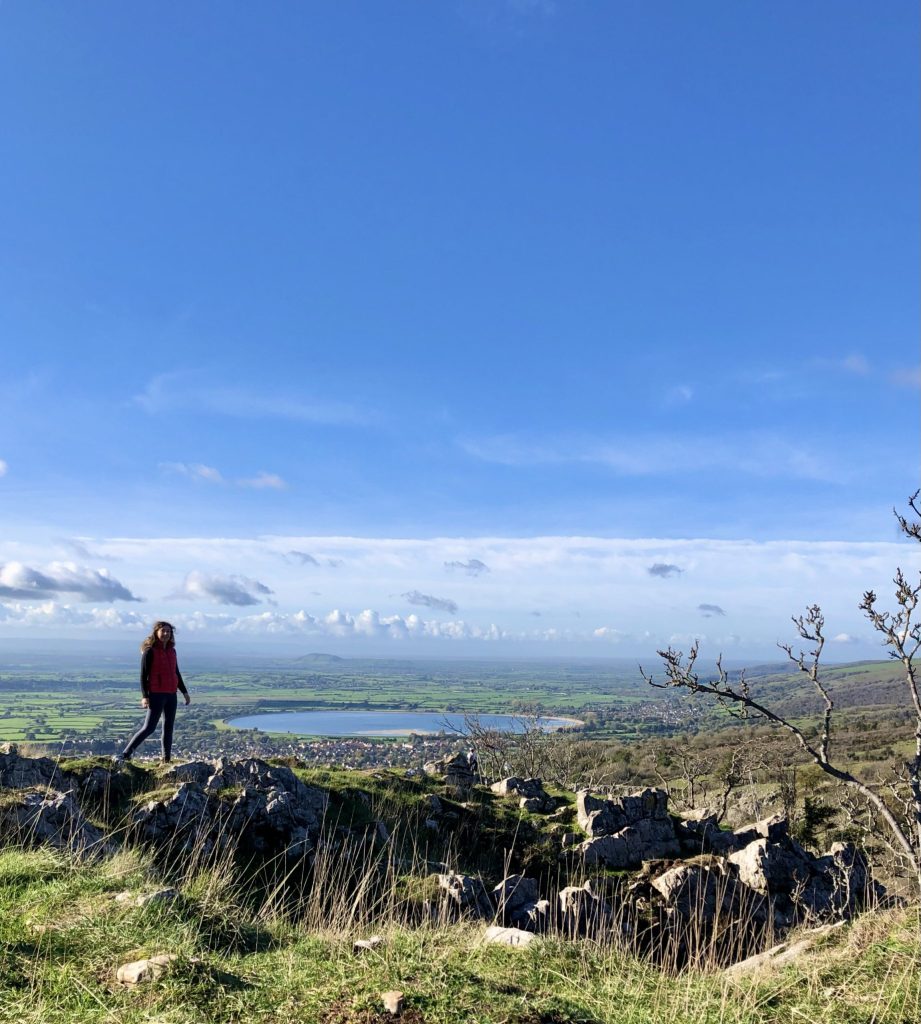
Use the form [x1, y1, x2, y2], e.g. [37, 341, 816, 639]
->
[639, 492, 921, 890]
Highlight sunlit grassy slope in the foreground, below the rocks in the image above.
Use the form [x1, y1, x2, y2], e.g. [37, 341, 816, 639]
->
[0, 850, 921, 1024]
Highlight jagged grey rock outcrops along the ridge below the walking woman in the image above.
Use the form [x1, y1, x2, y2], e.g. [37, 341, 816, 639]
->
[0, 748, 882, 955]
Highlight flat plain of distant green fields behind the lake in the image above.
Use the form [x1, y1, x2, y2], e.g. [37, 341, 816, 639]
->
[0, 655, 904, 748]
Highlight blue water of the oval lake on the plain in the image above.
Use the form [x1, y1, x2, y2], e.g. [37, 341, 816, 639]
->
[227, 711, 575, 736]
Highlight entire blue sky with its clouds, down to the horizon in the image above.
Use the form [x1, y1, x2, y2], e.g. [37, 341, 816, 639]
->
[0, 0, 921, 655]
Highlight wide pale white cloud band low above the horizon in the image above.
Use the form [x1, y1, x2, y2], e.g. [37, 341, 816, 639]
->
[0, 536, 921, 659]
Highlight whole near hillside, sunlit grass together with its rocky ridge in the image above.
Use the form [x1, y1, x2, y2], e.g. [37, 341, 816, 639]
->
[0, 751, 921, 1024]
